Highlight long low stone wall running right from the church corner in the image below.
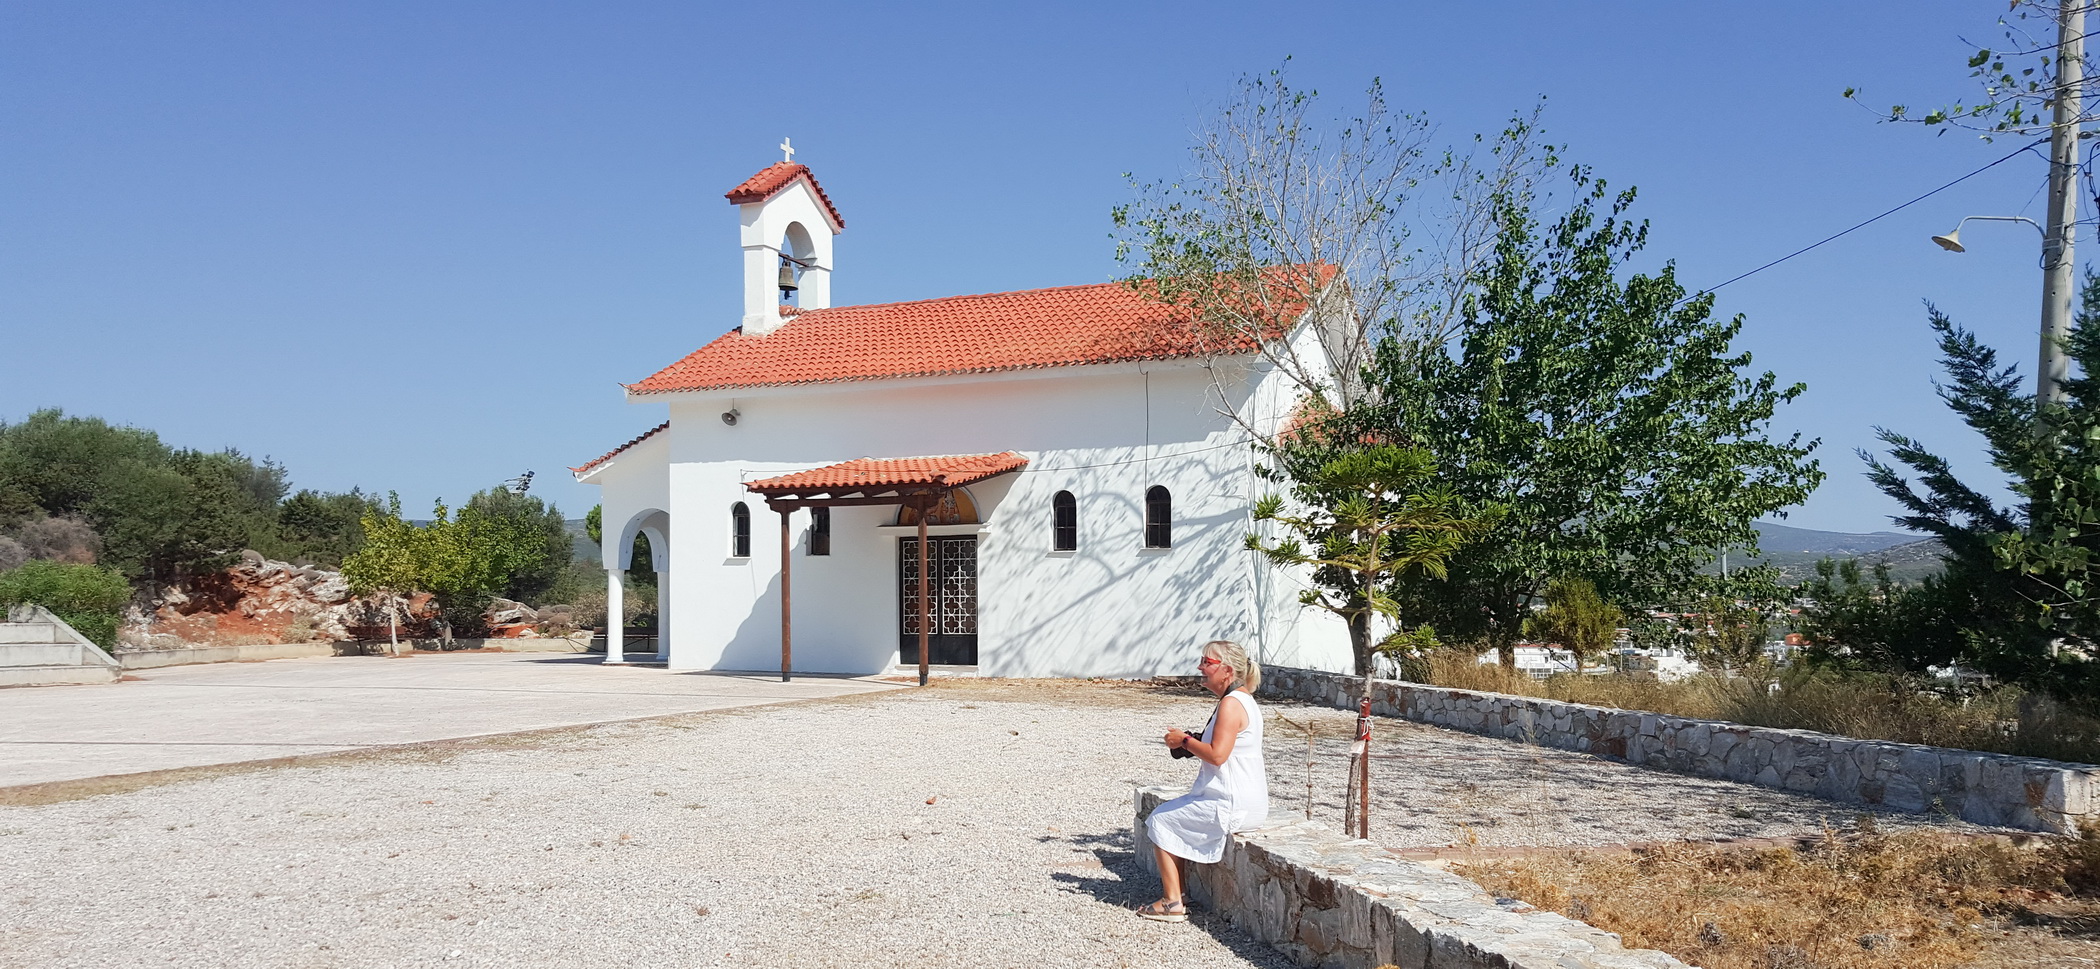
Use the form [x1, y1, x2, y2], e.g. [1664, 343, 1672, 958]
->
[1260, 668, 2100, 834]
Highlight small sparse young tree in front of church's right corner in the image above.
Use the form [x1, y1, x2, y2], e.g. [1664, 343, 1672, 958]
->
[1247, 446, 1502, 675]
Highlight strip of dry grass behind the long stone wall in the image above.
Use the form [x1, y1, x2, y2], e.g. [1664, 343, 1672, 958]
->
[1426, 652, 2100, 763]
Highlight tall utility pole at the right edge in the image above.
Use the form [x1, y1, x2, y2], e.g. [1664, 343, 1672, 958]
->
[2035, 0, 2085, 404]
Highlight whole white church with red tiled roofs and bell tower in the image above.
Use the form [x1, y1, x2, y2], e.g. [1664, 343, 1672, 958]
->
[573, 153, 1350, 677]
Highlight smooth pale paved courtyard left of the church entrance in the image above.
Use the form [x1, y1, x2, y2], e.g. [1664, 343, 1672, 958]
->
[0, 654, 895, 788]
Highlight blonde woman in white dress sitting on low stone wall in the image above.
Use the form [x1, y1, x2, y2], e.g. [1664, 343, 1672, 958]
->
[1138, 639, 1268, 923]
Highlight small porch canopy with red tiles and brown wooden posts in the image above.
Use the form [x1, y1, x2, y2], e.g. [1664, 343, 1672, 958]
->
[743, 452, 1029, 685]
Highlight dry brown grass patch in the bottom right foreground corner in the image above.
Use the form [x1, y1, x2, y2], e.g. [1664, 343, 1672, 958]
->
[1455, 828, 2100, 969]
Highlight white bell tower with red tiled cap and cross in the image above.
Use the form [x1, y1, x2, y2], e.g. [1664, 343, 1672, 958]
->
[725, 139, 846, 336]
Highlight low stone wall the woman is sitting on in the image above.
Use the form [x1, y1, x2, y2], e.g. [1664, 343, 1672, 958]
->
[1132, 788, 1684, 969]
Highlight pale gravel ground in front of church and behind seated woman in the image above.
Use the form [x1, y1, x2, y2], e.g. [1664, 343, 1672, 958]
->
[0, 683, 1999, 967]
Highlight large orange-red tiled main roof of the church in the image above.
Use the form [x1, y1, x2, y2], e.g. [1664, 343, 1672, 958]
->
[628, 269, 1331, 393]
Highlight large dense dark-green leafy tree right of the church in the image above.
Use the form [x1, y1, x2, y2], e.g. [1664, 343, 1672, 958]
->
[1363, 166, 1823, 664]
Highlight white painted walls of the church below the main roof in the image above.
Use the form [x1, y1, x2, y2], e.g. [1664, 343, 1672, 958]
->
[590, 351, 1348, 677]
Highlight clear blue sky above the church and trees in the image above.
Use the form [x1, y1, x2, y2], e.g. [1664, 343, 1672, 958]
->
[0, 2, 2066, 530]
